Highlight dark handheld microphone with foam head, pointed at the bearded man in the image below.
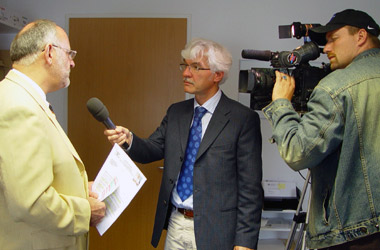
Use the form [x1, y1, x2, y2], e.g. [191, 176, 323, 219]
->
[87, 97, 129, 150]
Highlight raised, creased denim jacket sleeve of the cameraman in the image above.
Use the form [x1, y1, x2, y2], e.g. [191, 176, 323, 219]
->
[263, 84, 344, 170]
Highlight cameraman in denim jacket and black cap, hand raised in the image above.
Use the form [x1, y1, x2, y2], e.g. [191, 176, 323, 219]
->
[263, 9, 380, 250]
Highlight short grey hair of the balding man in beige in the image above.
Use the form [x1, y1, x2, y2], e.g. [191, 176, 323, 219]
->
[10, 19, 57, 66]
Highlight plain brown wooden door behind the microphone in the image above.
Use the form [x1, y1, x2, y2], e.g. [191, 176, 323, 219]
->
[68, 18, 187, 250]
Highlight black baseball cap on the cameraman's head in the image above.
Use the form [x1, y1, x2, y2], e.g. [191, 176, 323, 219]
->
[309, 9, 380, 45]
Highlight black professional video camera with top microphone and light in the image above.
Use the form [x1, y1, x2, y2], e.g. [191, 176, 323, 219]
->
[239, 22, 330, 113]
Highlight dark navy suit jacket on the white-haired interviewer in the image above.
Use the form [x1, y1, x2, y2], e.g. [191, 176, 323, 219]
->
[129, 94, 263, 250]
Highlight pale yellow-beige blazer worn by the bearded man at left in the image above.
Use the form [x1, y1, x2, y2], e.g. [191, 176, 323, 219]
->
[0, 71, 91, 250]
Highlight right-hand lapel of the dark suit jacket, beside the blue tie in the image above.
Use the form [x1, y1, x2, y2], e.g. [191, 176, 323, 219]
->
[197, 93, 230, 159]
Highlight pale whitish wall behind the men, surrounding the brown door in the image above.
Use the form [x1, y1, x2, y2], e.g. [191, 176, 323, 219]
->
[0, 0, 380, 205]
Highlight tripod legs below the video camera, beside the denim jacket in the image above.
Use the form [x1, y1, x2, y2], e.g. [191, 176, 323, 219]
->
[285, 169, 311, 250]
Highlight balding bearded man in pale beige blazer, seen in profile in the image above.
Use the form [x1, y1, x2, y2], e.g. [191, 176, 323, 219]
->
[0, 20, 106, 250]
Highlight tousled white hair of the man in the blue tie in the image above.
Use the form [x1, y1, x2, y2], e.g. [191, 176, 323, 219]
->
[181, 38, 232, 83]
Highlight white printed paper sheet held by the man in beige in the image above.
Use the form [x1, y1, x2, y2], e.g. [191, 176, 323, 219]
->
[92, 144, 146, 235]
